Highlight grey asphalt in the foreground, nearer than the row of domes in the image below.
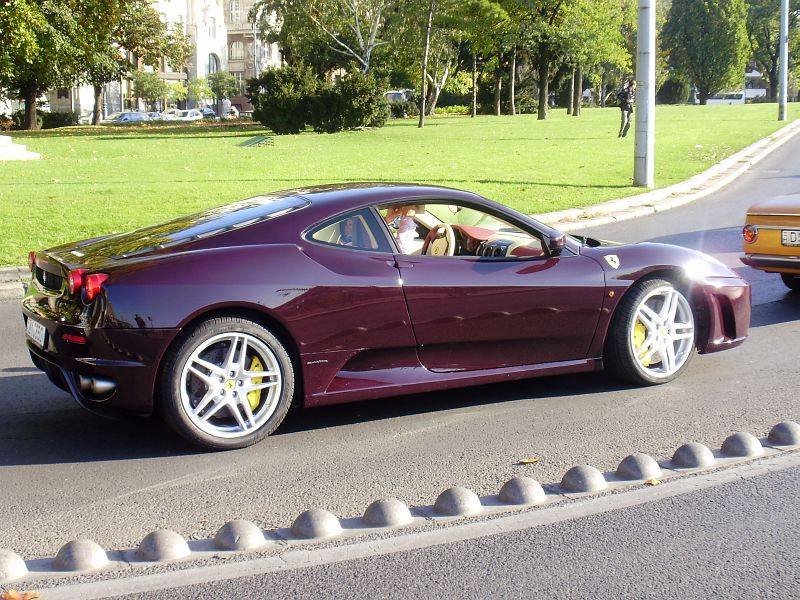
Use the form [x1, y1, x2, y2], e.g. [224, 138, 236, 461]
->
[111, 458, 800, 600]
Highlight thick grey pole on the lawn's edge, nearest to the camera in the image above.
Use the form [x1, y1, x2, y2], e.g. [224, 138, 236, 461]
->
[633, 0, 652, 188]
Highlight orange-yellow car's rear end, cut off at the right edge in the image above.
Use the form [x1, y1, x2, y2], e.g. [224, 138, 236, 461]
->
[742, 195, 800, 291]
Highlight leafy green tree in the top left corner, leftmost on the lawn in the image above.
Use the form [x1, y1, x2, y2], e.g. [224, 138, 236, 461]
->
[0, 0, 83, 129]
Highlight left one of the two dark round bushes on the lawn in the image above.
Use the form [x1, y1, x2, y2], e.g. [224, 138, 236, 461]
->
[247, 64, 320, 135]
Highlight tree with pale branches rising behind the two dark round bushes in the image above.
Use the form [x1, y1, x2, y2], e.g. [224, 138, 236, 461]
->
[250, 0, 395, 74]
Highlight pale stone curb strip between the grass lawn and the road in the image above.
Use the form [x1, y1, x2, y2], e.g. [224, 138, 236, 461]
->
[0, 119, 800, 300]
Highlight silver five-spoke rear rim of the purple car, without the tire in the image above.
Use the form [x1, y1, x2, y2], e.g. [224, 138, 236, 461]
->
[180, 333, 283, 438]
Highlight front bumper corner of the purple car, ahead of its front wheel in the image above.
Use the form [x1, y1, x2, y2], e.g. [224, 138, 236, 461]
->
[697, 277, 752, 354]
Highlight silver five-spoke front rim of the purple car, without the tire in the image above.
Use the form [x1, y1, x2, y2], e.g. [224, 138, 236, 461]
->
[628, 285, 694, 379]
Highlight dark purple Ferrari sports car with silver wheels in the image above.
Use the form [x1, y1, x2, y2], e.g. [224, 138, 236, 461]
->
[22, 183, 750, 449]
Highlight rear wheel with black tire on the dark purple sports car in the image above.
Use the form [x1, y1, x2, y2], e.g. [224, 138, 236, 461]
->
[158, 316, 295, 450]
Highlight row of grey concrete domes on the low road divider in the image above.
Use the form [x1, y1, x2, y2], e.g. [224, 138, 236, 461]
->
[0, 421, 800, 597]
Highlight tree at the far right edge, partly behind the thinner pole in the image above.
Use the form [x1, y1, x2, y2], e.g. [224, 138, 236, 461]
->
[747, 0, 800, 102]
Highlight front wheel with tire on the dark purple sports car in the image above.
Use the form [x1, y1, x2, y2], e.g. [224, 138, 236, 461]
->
[605, 279, 695, 385]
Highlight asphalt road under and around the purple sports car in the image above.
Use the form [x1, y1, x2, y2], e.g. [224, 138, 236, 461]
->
[0, 132, 800, 560]
